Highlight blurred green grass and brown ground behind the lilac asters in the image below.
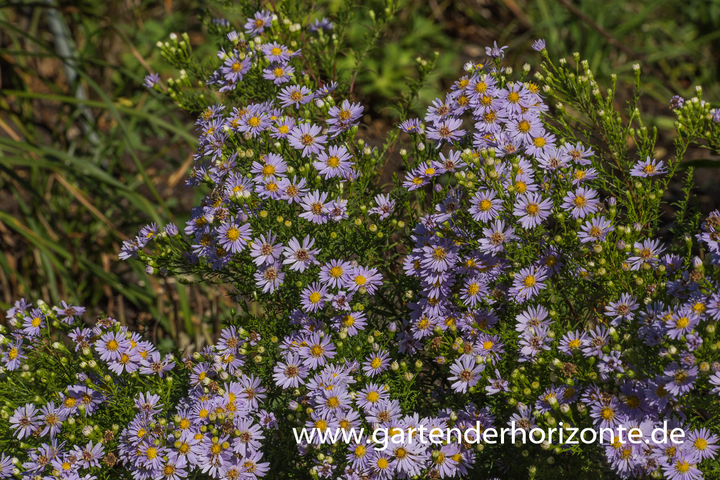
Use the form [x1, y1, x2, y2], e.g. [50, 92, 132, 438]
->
[0, 0, 720, 349]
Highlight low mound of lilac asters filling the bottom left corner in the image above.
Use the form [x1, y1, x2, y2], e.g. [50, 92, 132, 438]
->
[0, 300, 277, 480]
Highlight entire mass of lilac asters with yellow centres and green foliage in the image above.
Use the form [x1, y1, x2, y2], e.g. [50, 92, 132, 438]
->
[0, 5, 720, 480]
